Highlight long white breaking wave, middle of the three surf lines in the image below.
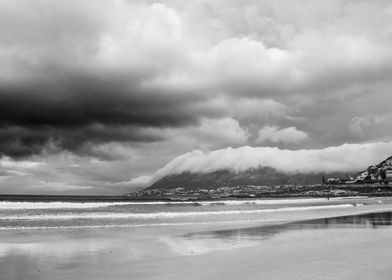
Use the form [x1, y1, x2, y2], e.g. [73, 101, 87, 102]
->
[0, 204, 356, 221]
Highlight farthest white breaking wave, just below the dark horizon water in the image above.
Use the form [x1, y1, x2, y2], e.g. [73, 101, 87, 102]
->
[0, 197, 366, 210]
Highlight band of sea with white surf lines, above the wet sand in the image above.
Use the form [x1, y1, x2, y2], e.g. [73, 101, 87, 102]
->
[0, 197, 390, 230]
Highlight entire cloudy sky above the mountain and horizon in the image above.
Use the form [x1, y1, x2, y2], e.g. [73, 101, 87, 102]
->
[0, 0, 392, 195]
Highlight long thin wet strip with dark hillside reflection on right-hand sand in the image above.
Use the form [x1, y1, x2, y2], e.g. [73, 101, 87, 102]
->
[182, 212, 392, 242]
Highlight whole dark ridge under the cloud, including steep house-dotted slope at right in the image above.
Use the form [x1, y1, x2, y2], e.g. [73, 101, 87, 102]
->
[146, 156, 392, 190]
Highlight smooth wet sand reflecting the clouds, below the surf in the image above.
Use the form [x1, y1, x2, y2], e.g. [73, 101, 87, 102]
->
[0, 205, 392, 280]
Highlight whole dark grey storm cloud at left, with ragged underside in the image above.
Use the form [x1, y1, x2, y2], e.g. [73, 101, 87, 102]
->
[0, 73, 195, 156]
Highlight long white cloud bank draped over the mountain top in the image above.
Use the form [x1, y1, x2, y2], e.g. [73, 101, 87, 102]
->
[133, 142, 392, 184]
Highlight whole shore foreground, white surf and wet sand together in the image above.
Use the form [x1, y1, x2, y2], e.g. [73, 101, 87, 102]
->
[0, 198, 392, 279]
